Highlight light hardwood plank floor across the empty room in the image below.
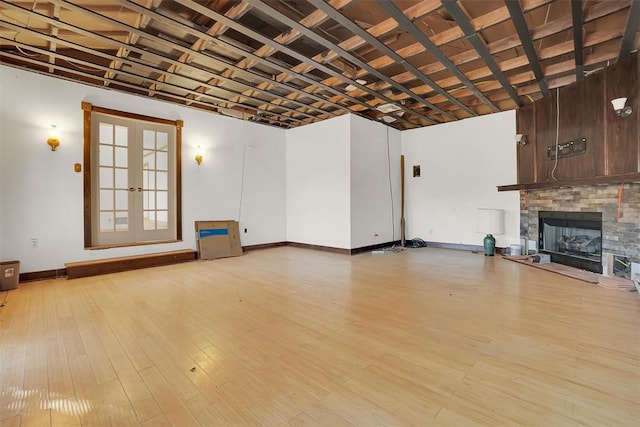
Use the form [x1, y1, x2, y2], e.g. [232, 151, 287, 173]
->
[0, 247, 640, 426]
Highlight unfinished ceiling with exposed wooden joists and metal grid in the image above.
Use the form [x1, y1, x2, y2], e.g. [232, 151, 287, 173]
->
[0, 0, 640, 129]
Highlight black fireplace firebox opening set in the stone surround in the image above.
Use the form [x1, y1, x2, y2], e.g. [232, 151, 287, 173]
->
[538, 211, 602, 273]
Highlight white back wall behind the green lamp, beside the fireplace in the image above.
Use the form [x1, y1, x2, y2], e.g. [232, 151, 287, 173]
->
[402, 111, 520, 247]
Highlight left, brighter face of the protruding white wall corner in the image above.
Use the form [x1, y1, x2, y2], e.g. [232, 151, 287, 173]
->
[286, 115, 351, 249]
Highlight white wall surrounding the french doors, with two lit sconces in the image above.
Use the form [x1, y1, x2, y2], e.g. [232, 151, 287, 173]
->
[0, 66, 286, 272]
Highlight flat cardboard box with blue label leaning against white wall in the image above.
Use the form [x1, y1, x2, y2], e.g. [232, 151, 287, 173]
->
[196, 221, 242, 259]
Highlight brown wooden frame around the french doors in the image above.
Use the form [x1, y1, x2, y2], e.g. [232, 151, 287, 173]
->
[81, 102, 184, 249]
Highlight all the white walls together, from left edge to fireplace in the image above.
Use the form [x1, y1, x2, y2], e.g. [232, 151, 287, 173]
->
[0, 66, 519, 272]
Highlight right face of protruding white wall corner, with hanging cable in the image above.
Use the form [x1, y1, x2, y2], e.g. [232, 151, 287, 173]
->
[350, 116, 402, 249]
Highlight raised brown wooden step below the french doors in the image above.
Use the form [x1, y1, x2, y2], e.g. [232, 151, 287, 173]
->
[65, 249, 196, 279]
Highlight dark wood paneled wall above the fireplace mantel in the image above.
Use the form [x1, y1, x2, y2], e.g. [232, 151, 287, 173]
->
[517, 54, 640, 184]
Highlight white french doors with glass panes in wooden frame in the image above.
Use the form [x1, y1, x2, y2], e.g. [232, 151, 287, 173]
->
[91, 113, 176, 246]
